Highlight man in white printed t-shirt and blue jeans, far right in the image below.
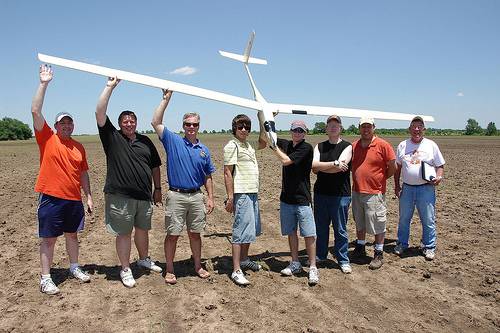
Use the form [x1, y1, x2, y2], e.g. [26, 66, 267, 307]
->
[394, 116, 446, 260]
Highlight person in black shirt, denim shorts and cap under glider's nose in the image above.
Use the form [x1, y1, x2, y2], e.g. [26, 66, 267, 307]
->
[275, 120, 319, 285]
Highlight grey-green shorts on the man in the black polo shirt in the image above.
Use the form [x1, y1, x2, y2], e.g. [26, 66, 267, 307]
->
[104, 193, 153, 236]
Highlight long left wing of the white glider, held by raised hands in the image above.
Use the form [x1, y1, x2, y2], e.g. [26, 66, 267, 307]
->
[38, 53, 262, 110]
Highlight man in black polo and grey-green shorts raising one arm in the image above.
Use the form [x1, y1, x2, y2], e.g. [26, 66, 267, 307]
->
[95, 78, 162, 288]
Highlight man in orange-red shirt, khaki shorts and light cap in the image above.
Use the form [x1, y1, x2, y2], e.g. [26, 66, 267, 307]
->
[351, 118, 397, 269]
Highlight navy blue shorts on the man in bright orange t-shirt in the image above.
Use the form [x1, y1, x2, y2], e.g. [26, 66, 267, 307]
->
[37, 193, 85, 238]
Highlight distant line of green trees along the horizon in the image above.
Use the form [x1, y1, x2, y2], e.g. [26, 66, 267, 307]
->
[0, 117, 500, 141]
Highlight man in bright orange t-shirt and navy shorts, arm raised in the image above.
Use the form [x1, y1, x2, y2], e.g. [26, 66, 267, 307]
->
[31, 65, 94, 295]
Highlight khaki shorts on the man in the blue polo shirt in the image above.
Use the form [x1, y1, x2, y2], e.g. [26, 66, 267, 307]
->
[165, 190, 207, 236]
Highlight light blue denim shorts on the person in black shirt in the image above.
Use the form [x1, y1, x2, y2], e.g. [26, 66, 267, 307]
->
[280, 201, 316, 237]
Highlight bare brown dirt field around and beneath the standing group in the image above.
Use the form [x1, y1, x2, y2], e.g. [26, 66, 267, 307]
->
[0, 135, 500, 332]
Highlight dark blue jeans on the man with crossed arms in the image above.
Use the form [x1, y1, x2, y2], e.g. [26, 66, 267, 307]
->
[314, 192, 351, 265]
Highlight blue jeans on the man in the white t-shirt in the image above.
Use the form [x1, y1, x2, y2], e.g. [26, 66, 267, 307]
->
[398, 184, 436, 248]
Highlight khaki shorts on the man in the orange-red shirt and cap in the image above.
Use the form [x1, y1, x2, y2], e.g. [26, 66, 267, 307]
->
[352, 191, 387, 235]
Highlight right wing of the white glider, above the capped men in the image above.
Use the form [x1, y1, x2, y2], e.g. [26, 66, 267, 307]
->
[269, 103, 434, 122]
